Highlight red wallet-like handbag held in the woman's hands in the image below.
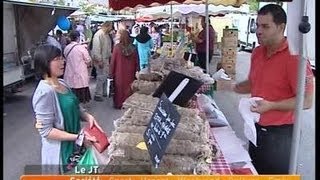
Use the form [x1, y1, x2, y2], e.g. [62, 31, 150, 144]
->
[84, 125, 110, 153]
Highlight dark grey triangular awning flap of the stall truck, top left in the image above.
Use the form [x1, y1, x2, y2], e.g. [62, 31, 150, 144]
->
[3, 1, 78, 58]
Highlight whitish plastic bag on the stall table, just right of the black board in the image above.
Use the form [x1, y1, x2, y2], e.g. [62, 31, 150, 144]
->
[197, 94, 229, 127]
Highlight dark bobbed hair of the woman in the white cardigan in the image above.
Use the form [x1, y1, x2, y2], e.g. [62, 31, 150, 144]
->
[34, 44, 62, 79]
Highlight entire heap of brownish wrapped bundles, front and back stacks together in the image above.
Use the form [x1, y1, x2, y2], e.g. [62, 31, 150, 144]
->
[105, 52, 219, 174]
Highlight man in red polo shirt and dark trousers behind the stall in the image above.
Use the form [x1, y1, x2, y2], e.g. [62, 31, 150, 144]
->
[234, 4, 314, 174]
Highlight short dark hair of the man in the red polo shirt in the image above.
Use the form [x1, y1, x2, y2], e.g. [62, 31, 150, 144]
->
[258, 4, 287, 25]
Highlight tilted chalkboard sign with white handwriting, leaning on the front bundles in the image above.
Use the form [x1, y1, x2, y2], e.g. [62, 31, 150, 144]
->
[143, 94, 180, 168]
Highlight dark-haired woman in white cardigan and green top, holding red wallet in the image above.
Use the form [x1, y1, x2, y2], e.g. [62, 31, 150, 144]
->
[32, 45, 102, 174]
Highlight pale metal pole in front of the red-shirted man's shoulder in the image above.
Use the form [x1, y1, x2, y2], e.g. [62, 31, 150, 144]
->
[289, 0, 307, 174]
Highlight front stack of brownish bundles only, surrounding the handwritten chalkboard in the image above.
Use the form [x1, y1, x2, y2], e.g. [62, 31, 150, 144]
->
[107, 93, 218, 174]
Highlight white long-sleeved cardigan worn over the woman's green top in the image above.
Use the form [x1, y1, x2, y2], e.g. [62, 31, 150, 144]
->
[32, 79, 85, 174]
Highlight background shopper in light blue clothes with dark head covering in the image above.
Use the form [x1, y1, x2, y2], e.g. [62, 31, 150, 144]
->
[133, 26, 153, 70]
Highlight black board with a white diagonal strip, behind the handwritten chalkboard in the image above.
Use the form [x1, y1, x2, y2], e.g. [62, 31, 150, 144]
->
[153, 71, 203, 106]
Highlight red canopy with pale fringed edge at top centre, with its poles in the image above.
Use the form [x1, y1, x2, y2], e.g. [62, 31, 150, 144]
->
[109, 0, 246, 73]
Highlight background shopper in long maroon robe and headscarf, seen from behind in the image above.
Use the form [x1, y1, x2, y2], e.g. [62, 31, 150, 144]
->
[110, 30, 139, 109]
